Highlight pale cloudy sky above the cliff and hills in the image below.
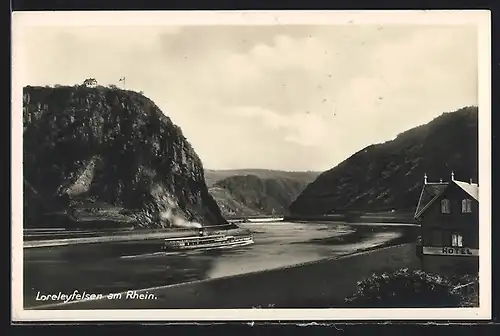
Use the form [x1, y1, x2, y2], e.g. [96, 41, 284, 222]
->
[20, 24, 478, 171]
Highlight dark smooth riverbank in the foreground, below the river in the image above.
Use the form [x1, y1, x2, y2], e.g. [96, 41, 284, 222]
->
[31, 243, 420, 310]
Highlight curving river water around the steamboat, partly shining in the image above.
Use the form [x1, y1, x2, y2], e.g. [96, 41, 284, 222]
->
[23, 222, 415, 308]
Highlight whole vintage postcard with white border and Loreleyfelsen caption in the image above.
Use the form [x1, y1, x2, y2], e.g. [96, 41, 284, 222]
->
[12, 11, 491, 321]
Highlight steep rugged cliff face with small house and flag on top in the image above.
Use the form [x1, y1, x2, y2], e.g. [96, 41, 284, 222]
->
[23, 86, 227, 228]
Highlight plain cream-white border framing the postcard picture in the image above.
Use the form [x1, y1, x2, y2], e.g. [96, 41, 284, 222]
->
[11, 10, 491, 321]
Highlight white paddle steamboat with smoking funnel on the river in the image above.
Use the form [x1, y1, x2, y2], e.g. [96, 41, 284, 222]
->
[163, 229, 254, 251]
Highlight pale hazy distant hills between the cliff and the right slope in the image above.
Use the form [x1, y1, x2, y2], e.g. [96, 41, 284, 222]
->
[205, 169, 319, 217]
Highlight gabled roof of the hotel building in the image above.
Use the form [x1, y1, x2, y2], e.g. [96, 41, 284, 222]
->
[415, 180, 479, 218]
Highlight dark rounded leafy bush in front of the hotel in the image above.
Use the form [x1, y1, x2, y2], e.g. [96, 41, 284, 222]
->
[346, 269, 463, 308]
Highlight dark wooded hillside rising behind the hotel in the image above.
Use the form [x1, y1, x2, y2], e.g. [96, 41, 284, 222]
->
[290, 107, 478, 215]
